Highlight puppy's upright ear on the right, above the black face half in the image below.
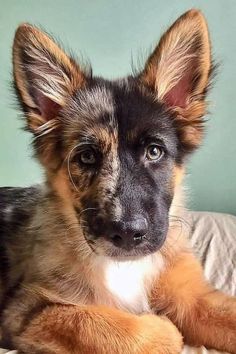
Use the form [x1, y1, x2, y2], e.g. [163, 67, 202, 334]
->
[140, 10, 212, 151]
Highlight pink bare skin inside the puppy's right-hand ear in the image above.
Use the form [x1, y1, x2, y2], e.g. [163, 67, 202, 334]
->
[164, 71, 193, 108]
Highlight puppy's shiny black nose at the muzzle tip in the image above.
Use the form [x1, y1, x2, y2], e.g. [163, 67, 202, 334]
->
[108, 216, 148, 249]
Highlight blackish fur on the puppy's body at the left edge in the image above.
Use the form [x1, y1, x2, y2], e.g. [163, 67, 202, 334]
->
[0, 187, 40, 303]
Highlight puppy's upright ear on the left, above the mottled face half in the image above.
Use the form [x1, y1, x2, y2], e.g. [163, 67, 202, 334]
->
[13, 24, 85, 136]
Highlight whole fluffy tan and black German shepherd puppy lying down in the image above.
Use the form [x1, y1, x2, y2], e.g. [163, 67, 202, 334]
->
[0, 10, 236, 354]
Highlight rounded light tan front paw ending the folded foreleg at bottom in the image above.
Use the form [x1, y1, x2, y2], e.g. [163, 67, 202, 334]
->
[136, 315, 183, 354]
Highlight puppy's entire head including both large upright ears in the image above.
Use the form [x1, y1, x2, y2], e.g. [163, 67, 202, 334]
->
[14, 10, 211, 258]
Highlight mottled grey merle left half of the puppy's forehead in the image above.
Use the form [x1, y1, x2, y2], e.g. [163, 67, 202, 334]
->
[62, 84, 117, 143]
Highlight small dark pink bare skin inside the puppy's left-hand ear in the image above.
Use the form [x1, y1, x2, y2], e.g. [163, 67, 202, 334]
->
[35, 93, 61, 120]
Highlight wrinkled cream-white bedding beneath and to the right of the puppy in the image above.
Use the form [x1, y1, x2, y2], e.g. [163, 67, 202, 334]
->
[0, 212, 236, 354]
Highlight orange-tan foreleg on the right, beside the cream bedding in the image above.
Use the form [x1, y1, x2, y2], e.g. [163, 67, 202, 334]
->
[151, 253, 236, 354]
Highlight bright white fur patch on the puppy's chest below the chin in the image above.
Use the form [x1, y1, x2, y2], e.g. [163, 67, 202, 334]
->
[93, 255, 164, 313]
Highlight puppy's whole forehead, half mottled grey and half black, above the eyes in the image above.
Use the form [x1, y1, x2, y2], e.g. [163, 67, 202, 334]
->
[65, 79, 174, 147]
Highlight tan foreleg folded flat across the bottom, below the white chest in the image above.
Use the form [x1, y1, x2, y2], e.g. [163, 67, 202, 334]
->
[6, 304, 182, 354]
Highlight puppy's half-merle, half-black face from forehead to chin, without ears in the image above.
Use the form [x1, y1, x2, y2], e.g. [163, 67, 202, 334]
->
[62, 78, 180, 256]
